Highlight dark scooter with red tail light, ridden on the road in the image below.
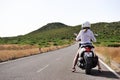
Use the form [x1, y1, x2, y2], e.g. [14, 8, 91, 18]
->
[77, 45, 98, 74]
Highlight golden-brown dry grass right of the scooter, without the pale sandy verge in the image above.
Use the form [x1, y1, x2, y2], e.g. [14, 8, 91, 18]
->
[95, 47, 120, 64]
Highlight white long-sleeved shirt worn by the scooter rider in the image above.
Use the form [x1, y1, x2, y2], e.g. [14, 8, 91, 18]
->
[76, 29, 96, 43]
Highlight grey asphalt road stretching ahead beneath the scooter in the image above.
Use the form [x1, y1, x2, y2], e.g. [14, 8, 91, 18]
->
[0, 44, 120, 80]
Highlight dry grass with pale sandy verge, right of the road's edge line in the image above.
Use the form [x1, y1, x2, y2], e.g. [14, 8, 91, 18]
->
[95, 47, 120, 72]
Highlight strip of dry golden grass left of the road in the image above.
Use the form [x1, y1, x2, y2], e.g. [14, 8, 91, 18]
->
[0, 44, 68, 62]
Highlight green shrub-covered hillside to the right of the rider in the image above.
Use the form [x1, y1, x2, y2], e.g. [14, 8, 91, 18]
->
[92, 22, 120, 46]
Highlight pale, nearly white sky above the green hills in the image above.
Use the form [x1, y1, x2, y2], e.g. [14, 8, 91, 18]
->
[0, 0, 120, 37]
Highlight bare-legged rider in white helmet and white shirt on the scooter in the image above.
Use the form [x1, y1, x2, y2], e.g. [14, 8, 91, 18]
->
[72, 22, 101, 72]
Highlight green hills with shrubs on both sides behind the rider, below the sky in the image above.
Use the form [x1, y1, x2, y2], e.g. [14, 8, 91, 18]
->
[0, 22, 120, 47]
